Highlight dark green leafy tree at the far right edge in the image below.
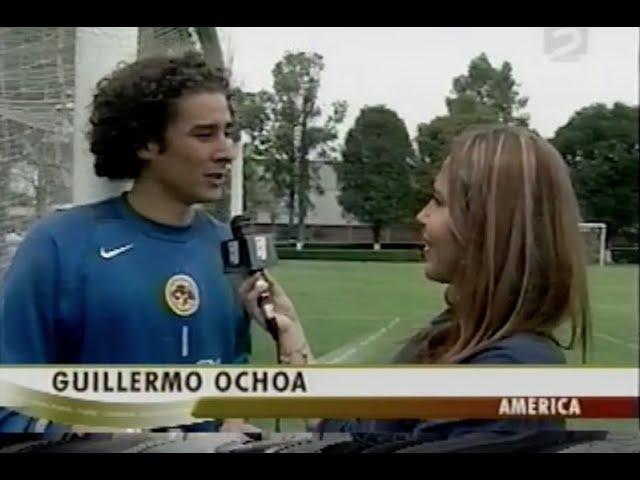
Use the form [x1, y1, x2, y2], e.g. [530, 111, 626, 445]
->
[551, 103, 639, 236]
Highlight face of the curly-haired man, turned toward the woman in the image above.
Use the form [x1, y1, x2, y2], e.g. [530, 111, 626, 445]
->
[141, 93, 234, 205]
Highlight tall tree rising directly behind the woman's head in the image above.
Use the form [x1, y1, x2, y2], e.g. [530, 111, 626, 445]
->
[414, 53, 529, 209]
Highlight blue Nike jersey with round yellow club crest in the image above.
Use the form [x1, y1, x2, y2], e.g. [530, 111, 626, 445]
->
[0, 196, 250, 430]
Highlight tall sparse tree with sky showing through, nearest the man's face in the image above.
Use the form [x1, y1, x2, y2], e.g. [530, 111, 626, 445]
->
[270, 52, 347, 245]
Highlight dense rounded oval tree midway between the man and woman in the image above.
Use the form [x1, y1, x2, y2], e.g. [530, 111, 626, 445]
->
[337, 106, 414, 248]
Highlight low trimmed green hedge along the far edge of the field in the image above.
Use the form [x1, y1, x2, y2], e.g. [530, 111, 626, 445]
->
[277, 247, 422, 262]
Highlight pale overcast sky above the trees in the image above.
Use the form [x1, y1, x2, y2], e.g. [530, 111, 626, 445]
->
[221, 27, 640, 137]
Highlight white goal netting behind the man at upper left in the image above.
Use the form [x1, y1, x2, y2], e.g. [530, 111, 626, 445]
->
[0, 27, 208, 287]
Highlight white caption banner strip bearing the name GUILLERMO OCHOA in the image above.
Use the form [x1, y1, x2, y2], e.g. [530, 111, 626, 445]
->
[0, 366, 639, 403]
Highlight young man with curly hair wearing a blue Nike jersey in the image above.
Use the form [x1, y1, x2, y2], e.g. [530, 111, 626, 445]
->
[0, 53, 250, 431]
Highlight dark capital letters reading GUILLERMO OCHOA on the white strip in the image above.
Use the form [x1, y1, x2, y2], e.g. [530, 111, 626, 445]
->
[51, 369, 307, 393]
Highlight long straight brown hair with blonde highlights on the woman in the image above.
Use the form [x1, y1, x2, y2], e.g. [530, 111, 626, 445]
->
[404, 125, 590, 363]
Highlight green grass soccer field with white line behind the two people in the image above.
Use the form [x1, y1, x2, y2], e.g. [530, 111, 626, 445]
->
[253, 260, 639, 366]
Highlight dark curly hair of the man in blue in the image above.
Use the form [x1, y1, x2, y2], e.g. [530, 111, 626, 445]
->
[88, 52, 233, 180]
